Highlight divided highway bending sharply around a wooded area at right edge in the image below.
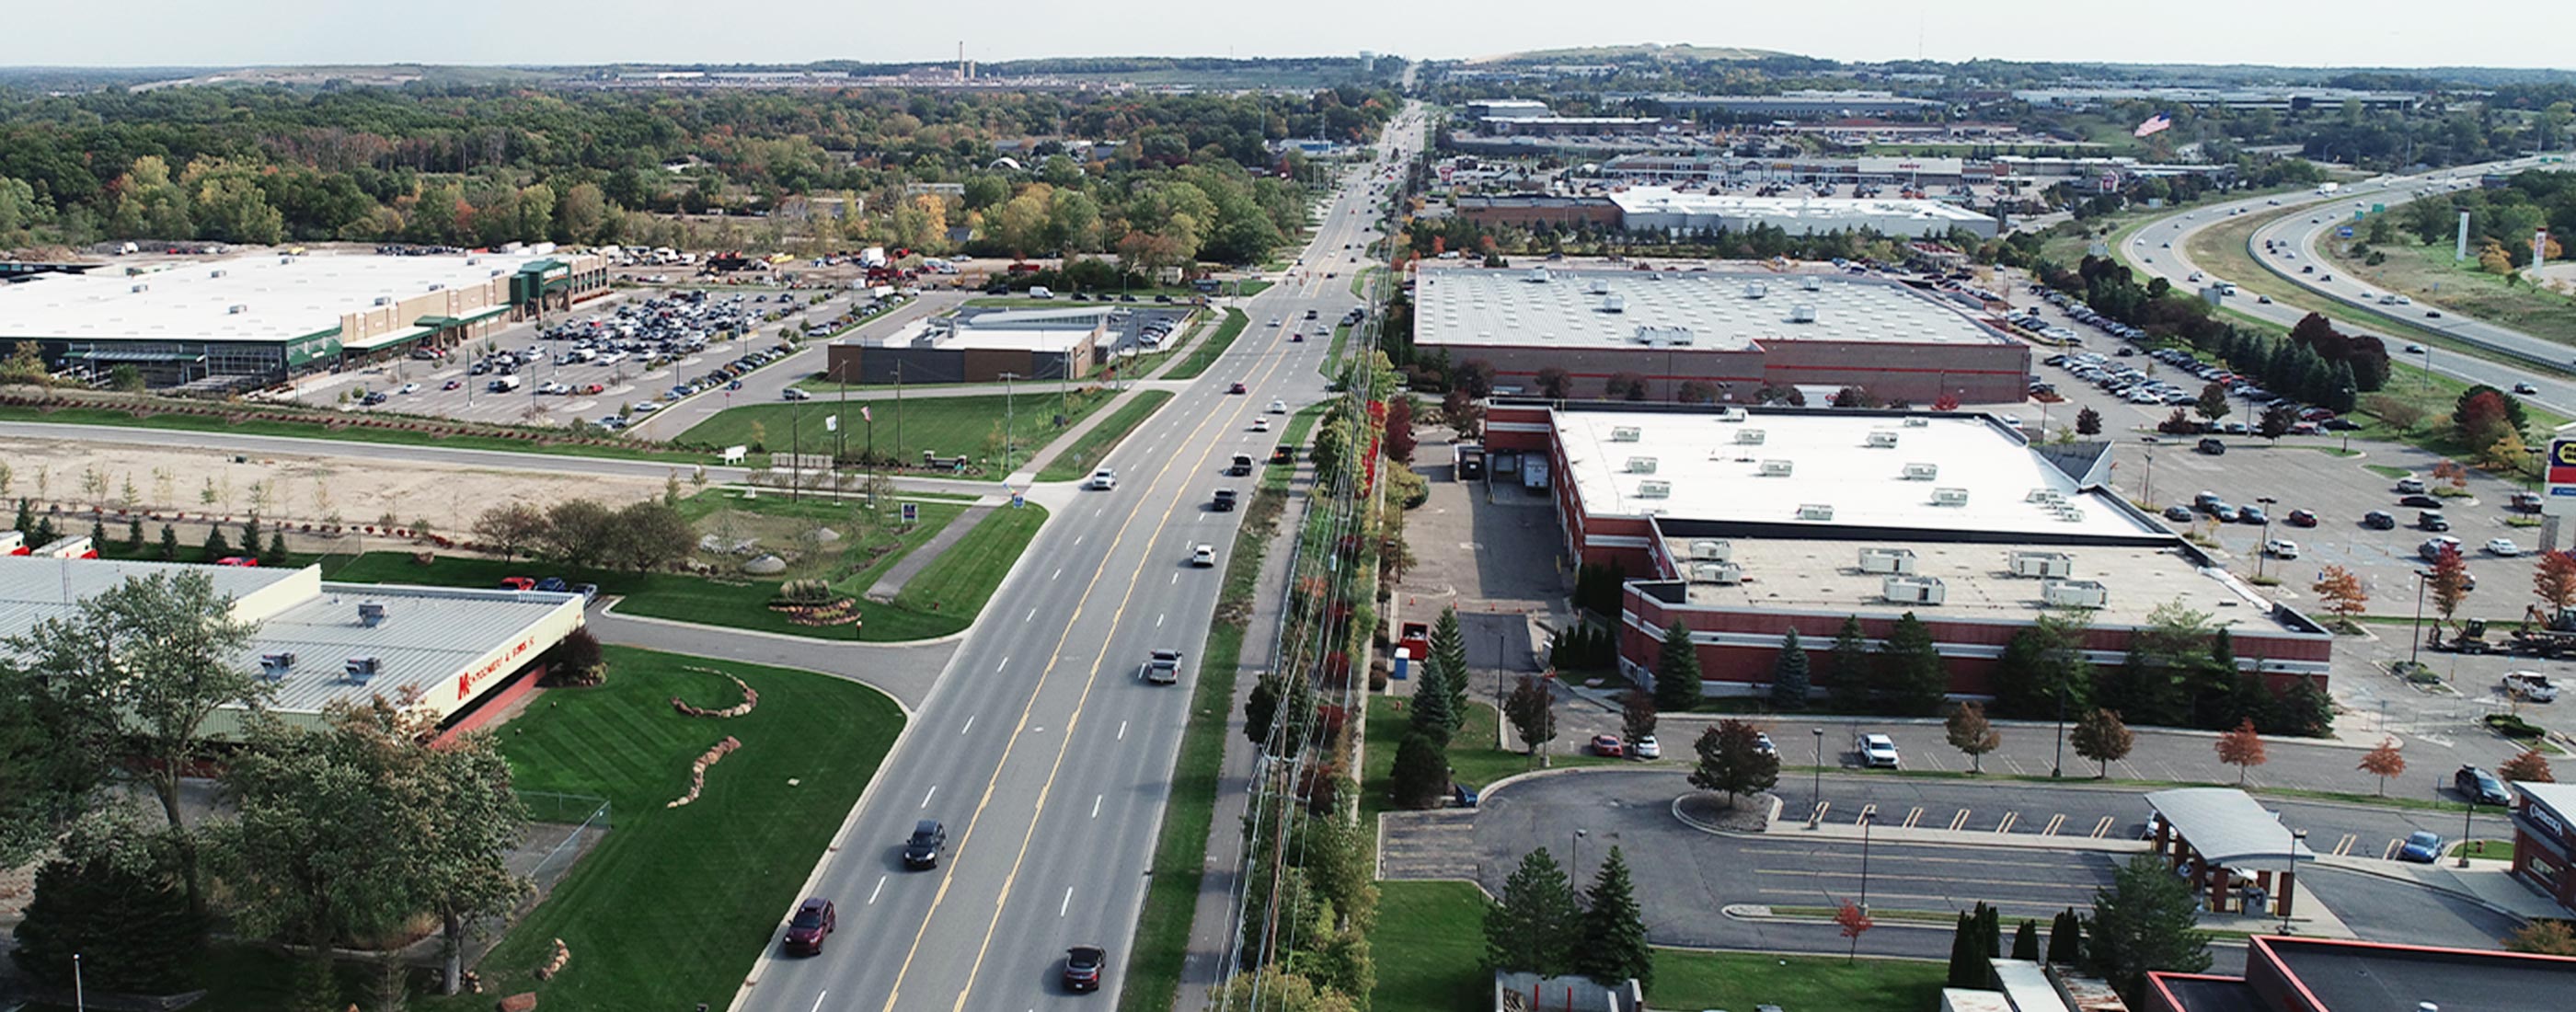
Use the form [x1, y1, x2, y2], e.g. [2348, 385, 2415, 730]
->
[2120, 157, 2576, 412]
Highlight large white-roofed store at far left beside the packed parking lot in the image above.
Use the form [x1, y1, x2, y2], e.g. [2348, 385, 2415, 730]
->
[0, 245, 608, 386]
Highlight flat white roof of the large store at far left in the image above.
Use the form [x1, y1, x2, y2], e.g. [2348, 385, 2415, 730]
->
[0, 252, 561, 339]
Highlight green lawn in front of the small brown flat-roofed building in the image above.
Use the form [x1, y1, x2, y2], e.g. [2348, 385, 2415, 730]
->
[680, 384, 1113, 481]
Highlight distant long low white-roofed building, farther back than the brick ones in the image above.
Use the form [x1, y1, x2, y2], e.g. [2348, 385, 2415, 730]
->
[1610, 186, 1999, 239]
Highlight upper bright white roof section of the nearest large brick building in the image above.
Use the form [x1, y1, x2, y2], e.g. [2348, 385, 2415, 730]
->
[1553, 409, 2171, 541]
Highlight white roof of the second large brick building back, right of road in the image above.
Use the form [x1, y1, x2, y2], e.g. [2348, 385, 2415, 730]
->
[1414, 268, 2012, 351]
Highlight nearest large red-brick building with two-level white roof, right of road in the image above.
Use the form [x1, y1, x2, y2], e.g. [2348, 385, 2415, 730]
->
[1487, 397, 2334, 696]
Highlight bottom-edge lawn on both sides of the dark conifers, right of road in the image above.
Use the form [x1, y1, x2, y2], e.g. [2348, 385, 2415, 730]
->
[1371, 880, 1950, 1012]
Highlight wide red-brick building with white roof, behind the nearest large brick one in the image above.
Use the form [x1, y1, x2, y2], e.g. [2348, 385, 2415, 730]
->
[1414, 268, 2030, 404]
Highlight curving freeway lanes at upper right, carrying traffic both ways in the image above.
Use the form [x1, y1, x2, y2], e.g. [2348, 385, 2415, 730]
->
[2120, 157, 2576, 412]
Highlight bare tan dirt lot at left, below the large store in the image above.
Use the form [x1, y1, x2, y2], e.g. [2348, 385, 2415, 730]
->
[0, 438, 662, 533]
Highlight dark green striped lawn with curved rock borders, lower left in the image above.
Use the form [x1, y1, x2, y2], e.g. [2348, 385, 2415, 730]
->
[415, 647, 904, 1009]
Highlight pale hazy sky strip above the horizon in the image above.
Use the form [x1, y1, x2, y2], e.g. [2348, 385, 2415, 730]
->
[0, 0, 2576, 70]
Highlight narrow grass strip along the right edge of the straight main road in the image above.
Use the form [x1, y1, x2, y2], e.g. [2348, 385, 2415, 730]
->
[1118, 489, 1288, 1012]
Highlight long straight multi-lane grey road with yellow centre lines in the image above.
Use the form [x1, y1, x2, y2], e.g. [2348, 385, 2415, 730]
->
[737, 104, 1420, 1012]
